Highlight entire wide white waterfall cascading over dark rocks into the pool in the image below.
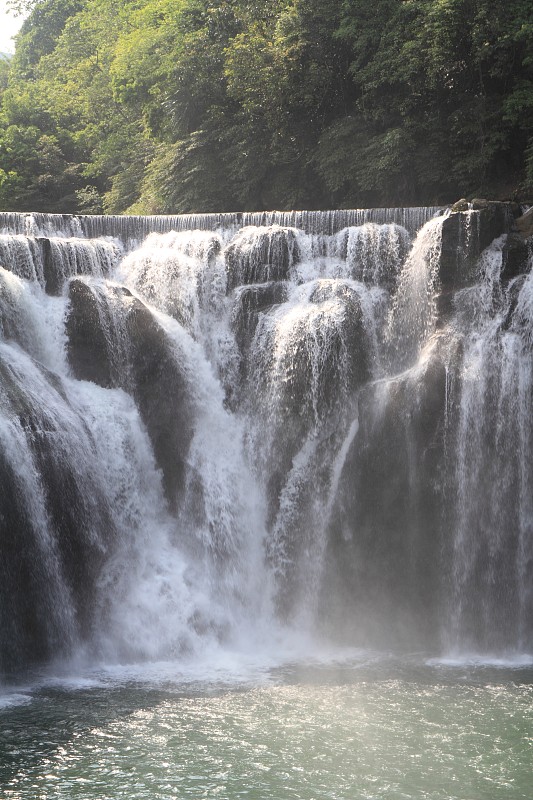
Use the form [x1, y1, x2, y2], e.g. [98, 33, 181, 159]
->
[0, 202, 533, 672]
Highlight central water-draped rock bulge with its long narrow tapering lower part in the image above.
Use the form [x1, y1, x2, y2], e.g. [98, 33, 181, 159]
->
[258, 280, 371, 619]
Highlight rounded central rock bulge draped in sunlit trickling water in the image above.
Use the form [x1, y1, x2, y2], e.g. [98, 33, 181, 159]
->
[251, 280, 370, 444]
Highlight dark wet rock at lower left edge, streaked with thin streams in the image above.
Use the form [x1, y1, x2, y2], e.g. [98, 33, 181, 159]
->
[0, 354, 115, 669]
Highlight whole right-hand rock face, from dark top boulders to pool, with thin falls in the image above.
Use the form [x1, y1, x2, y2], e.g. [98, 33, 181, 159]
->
[320, 201, 533, 649]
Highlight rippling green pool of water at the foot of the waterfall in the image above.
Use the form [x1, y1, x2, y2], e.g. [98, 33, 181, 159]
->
[0, 658, 533, 800]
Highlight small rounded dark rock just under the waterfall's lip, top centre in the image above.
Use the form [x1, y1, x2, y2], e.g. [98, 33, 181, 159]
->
[224, 225, 299, 291]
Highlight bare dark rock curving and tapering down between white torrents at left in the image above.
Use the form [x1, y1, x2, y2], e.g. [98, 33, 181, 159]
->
[66, 279, 193, 509]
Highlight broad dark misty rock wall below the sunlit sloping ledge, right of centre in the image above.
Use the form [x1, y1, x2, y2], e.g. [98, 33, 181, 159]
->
[322, 331, 462, 647]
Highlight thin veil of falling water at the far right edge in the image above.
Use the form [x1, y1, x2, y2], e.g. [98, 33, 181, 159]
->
[448, 240, 533, 649]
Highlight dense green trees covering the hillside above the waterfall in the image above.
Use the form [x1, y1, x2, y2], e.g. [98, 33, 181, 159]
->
[0, 0, 533, 213]
